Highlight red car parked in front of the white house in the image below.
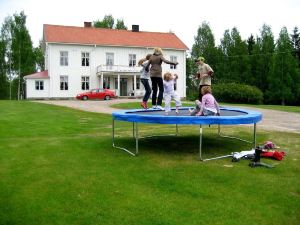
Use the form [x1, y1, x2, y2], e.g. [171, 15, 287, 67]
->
[76, 88, 116, 100]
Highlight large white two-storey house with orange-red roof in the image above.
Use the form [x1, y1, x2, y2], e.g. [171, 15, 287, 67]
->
[24, 23, 188, 99]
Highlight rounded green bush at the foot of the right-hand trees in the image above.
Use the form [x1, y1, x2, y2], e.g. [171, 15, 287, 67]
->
[212, 83, 263, 104]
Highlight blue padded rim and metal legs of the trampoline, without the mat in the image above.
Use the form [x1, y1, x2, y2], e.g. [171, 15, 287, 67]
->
[112, 108, 262, 161]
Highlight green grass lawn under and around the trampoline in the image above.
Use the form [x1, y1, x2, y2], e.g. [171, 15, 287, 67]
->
[0, 101, 300, 225]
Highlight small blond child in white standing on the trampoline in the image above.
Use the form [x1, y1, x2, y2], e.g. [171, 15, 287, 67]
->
[163, 72, 181, 115]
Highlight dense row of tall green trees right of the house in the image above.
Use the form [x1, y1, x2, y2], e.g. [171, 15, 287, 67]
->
[187, 22, 300, 105]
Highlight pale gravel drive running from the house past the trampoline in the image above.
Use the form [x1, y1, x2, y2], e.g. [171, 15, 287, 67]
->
[35, 99, 300, 133]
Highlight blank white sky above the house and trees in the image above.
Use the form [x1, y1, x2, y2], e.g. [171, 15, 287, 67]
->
[0, 0, 300, 49]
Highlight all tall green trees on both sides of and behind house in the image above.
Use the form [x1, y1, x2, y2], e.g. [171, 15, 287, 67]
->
[0, 11, 300, 105]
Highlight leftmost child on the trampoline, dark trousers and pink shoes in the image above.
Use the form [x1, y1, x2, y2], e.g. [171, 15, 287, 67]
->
[138, 54, 152, 109]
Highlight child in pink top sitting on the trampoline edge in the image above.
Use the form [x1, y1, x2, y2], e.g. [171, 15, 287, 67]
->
[189, 86, 220, 116]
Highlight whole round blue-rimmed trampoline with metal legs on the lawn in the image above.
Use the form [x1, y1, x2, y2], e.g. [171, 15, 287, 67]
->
[112, 107, 262, 161]
